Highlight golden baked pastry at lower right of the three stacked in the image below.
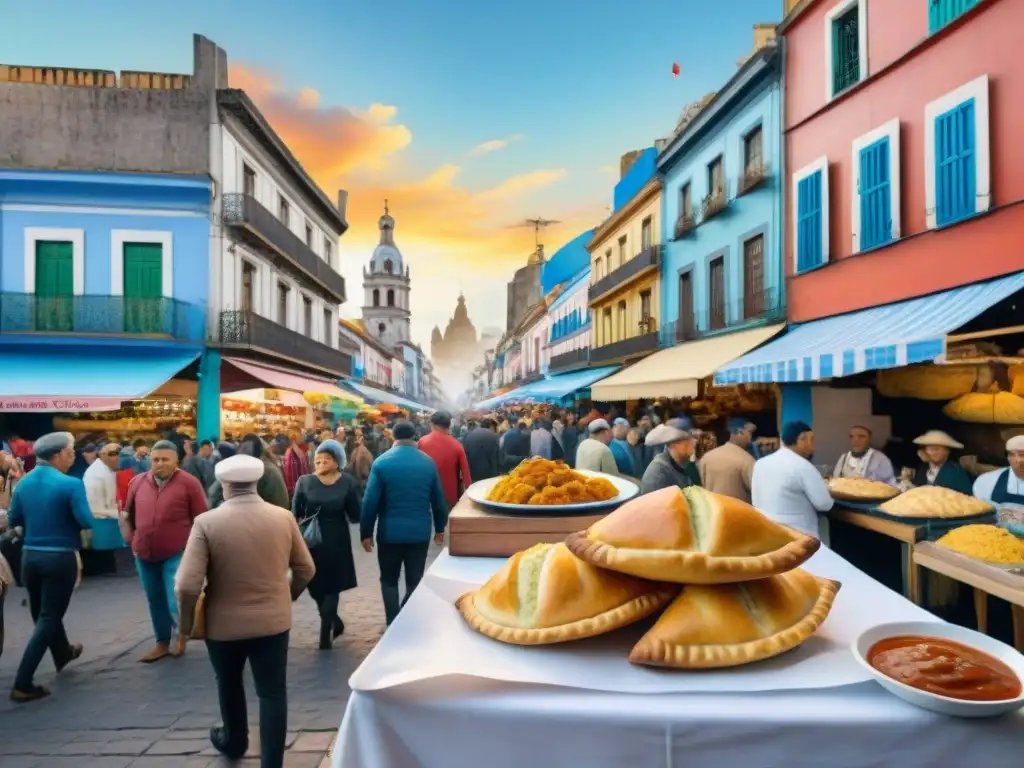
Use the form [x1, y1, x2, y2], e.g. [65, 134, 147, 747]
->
[630, 568, 840, 669]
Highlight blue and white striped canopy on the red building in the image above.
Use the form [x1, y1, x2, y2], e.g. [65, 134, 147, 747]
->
[715, 272, 1024, 384]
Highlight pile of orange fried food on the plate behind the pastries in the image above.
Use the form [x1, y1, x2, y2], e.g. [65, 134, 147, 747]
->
[487, 457, 618, 507]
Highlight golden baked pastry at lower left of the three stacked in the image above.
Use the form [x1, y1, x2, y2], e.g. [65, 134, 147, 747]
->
[456, 544, 679, 645]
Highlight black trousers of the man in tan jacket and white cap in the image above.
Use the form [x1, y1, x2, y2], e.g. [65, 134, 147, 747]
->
[206, 632, 289, 768]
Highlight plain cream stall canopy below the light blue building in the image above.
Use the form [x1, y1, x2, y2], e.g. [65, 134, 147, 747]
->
[591, 324, 785, 402]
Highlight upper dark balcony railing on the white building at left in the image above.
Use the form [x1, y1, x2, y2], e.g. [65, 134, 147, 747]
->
[223, 193, 345, 303]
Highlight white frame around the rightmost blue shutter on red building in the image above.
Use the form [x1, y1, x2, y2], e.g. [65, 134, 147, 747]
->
[925, 75, 992, 229]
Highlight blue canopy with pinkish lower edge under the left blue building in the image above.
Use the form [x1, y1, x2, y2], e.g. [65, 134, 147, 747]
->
[0, 345, 201, 412]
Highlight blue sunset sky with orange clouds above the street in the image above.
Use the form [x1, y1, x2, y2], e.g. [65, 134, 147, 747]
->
[0, 0, 782, 344]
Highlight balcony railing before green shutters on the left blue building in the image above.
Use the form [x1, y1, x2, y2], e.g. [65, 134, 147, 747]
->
[0, 293, 206, 342]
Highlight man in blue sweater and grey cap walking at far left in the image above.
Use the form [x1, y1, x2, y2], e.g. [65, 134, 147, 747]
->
[7, 432, 93, 703]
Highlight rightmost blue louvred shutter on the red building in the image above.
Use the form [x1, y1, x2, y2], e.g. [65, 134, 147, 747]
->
[935, 98, 977, 226]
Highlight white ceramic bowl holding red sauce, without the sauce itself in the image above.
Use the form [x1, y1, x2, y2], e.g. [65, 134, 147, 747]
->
[850, 622, 1024, 718]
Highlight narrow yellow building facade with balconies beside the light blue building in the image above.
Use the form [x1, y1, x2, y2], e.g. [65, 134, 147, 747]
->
[587, 177, 662, 366]
